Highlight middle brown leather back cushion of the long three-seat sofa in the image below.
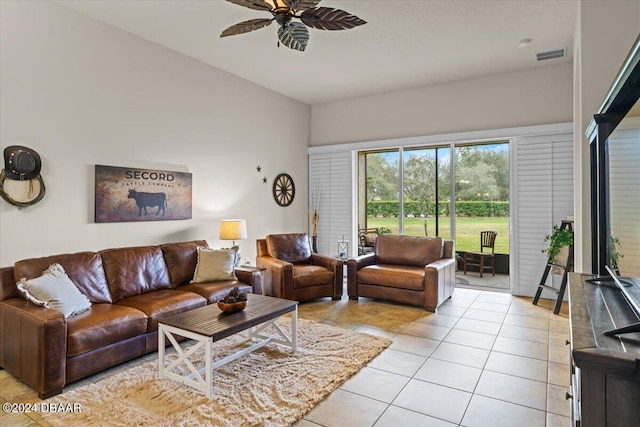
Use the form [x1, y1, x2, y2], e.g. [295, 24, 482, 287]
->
[100, 246, 171, 302]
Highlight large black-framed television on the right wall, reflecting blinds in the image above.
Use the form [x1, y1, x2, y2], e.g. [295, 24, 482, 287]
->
[587, 36, 640, 277]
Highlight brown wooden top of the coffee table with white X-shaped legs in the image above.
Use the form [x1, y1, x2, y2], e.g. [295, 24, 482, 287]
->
[158, 294, 298, 341]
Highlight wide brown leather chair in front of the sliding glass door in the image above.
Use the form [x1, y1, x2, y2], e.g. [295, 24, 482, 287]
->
[347, 234, 456, 312]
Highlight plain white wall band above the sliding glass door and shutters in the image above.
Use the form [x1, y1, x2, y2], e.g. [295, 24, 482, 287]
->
[311, 63, 573, 146]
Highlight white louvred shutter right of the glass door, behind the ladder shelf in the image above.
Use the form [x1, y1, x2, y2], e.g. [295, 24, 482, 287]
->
[512, 134, 573, 299]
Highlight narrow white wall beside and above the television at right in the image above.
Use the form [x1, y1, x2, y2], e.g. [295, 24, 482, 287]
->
[574, 0, 640, 272]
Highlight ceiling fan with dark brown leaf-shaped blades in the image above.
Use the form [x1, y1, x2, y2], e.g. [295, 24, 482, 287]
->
[220, 0, 366, 51]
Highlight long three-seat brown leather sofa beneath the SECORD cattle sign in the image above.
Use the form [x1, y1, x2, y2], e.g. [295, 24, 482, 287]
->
[0, 240, 262, 399]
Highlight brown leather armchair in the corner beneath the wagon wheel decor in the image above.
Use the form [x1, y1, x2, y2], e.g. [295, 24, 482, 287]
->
[256, 233, 343, 301]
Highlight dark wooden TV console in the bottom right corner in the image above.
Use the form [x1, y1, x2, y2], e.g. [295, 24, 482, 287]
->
[567, 273, 640, 427]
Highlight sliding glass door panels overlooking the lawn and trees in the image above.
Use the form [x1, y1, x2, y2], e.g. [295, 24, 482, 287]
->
[358, 141, 509, 254]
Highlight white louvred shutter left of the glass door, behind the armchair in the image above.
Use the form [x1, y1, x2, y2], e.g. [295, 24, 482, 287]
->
[309, 151, 357, 255]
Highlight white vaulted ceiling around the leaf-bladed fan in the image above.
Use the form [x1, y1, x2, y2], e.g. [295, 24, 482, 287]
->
[59, 0, 577, 105]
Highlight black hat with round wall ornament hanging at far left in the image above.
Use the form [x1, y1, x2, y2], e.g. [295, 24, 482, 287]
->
[0, 145, 46, 208]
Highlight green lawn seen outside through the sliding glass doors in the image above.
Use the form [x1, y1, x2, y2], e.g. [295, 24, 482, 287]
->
[367, 217, 509, 254]
